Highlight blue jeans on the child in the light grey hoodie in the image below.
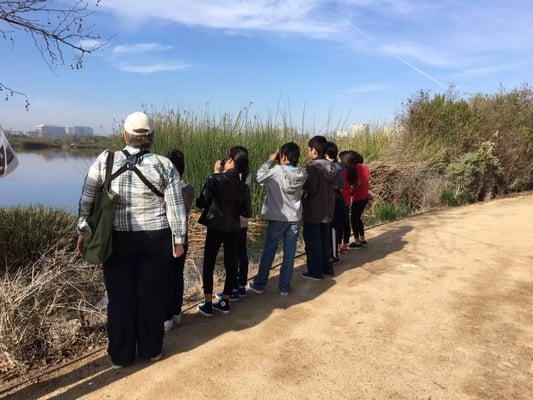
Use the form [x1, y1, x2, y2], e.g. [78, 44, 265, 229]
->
[254, 221, 300, 292]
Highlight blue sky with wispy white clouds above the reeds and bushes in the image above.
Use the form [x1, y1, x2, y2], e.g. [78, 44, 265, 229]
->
[0, 0, 533, 133]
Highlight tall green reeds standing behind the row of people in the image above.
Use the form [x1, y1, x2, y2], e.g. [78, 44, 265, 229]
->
[116, 108, 394, 215]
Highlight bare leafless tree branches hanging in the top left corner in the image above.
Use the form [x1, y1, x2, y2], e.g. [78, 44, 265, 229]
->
[0, 0, 107, 109]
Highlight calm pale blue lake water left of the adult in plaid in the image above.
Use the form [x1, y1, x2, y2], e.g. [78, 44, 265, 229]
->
[0, 150, 98, 212]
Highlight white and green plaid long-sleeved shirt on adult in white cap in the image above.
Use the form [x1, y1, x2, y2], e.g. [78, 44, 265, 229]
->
[77, 146, 187, 244]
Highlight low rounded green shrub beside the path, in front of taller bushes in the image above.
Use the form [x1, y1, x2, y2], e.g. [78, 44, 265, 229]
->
[448, 142, 503, 204]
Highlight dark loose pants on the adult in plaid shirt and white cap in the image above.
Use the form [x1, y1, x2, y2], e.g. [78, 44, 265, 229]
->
[104, 229, 172, 365]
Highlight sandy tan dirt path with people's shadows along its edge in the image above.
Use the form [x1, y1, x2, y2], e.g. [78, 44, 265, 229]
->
[5, 195, 533, 400]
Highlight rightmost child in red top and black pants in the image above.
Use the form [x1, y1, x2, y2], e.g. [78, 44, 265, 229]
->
[350, 152, 370, 249]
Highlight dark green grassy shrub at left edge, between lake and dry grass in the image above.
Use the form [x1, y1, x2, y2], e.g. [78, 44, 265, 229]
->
[0, 206, 76, 273]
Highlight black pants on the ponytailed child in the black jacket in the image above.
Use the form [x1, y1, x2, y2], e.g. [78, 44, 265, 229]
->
[203, 228, 240, 295]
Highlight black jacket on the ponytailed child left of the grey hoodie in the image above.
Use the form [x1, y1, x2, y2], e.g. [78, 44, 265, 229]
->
[196, 169, 252, 232]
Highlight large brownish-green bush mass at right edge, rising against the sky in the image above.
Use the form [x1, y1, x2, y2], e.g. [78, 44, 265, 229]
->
[399, 84, 533, 191]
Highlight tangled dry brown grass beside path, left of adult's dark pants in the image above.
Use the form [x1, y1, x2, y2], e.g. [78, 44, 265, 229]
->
[0, 242, 105, 379]
